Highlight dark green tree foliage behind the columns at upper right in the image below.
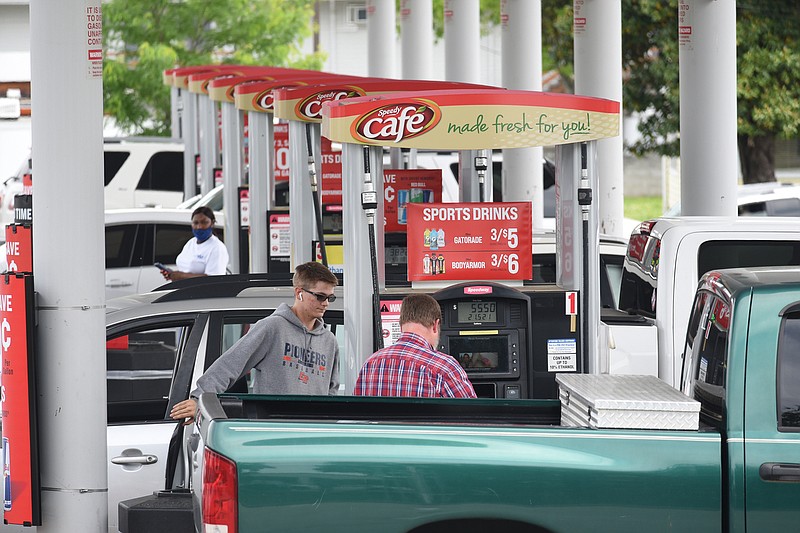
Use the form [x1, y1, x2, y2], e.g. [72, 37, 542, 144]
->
[542, 0, 800, 183]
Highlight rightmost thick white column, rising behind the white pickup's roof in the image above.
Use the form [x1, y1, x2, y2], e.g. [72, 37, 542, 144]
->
[678, 0, 736, 216]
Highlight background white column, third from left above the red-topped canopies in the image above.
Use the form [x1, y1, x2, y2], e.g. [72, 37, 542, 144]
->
[444, 0, 481, 83]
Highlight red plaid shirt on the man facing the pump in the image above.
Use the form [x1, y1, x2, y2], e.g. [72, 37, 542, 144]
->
[353, 333, 475, 398]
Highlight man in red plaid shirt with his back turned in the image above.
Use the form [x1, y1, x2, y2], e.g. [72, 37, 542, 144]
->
[353, 294, 475, 398]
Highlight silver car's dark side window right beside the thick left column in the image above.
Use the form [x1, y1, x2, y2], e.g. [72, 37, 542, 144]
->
[106, 320, 193, 424]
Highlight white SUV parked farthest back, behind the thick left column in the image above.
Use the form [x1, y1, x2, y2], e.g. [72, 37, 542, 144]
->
[0, 137, 183, 227]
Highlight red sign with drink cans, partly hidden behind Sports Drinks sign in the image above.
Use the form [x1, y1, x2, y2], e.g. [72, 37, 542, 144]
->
[383, 168, 442, 233]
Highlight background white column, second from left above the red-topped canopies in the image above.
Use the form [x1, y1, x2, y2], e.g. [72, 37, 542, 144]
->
[400, 0, 436, 80]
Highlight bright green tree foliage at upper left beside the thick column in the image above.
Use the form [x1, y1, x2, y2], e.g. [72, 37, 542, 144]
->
[103, 0, 323, 135]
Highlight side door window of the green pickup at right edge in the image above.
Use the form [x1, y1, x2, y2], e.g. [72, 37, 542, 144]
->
[778, 308, 800, 431]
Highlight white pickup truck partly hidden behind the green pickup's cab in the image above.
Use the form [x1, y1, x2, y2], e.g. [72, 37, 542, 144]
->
[609, 217, 800, 387]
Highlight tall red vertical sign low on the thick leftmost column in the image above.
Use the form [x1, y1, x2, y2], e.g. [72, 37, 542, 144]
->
[0, 274, 41, 525]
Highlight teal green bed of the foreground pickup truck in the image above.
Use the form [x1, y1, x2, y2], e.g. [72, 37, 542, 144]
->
[200, 395, 722, 533]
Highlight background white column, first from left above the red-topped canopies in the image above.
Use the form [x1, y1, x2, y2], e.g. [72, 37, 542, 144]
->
[367, 0, 397, 78]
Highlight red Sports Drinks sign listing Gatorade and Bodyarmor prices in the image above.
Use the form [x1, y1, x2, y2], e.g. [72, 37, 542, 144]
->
[406, 202, 533, 281]
